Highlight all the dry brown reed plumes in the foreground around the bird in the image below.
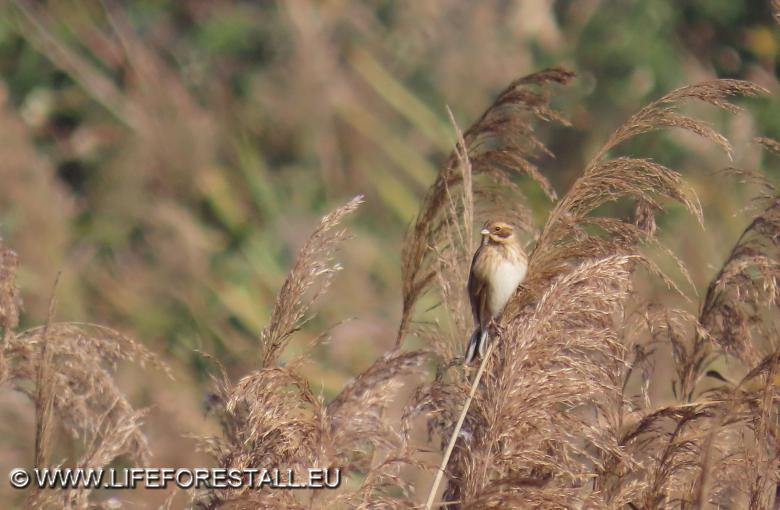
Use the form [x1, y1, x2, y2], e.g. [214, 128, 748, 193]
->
[0, 36, 780, 509]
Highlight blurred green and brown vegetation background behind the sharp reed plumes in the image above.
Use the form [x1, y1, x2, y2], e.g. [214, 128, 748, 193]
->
[0, 0, 780, 504]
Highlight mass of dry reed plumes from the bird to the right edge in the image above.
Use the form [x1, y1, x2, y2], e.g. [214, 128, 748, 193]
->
[408, 75, 780, 508]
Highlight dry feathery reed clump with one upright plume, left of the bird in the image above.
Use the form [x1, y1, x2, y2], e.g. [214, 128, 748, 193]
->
[193, 197, 427, 508]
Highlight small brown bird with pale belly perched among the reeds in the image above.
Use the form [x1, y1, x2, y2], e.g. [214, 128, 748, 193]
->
[466, 221, 528, 363]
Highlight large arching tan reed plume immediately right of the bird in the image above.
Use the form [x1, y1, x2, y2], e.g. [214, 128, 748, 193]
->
[417, 74, 766, 508]
